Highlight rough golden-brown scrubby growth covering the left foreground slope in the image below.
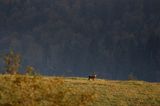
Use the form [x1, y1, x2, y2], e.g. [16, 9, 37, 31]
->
[0, 75, 95, 106]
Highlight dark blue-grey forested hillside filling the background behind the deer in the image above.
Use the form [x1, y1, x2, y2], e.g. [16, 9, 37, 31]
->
[0, 0, 160, 81]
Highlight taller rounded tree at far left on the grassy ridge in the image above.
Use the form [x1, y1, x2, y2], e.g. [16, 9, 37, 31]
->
[4, 51, 21, 74]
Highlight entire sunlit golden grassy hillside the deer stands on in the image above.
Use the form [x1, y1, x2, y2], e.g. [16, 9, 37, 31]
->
[0, 75, 160, 106]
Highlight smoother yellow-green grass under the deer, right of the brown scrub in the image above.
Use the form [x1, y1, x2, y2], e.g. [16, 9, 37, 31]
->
[65, 78, 160, 106]
